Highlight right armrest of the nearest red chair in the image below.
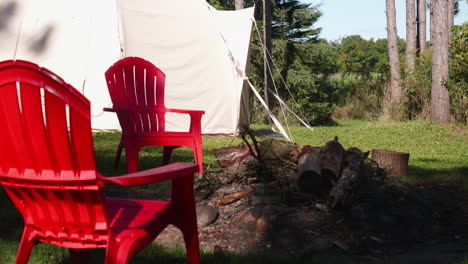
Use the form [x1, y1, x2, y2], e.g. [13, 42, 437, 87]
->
[100, 162, 198, 186]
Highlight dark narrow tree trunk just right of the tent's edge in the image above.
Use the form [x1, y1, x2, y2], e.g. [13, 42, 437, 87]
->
[263, 0, 273, 114]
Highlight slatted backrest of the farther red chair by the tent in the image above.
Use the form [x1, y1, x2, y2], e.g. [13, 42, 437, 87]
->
[105, 57, 166, 135]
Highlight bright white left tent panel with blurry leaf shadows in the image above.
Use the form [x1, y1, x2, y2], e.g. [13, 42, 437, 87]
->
[0, 0, 121, 129]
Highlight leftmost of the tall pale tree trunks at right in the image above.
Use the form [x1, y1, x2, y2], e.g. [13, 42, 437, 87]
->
[386, 0, 401, 103]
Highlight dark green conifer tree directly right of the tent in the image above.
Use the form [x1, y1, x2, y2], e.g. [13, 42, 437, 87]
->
[250, 0, 337, 124]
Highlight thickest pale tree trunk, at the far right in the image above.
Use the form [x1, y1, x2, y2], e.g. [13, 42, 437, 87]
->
[431, 0, 451, 123]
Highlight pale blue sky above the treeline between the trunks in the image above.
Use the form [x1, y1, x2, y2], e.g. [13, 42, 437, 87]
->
[302, 0, 468, 41]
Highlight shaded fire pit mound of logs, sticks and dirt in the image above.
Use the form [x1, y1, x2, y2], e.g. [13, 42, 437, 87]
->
[177, 137, 448, 256]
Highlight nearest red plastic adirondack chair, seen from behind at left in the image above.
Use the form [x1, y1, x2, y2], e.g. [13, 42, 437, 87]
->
[0, 61, 200, 264]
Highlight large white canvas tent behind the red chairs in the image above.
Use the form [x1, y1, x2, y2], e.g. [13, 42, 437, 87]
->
[0, 0, 253, 135]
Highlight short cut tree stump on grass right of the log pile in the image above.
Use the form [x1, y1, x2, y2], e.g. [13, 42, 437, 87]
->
[372, 149, 409, 177]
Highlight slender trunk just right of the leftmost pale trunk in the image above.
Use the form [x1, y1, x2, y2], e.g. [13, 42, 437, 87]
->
[406, 0, 417, 72]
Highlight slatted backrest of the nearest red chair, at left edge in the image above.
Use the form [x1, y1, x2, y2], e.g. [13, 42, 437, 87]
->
[0, 61, 108, 245]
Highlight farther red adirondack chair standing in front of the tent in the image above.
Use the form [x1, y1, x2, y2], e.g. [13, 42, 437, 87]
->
[104, 57, 205, 174]
